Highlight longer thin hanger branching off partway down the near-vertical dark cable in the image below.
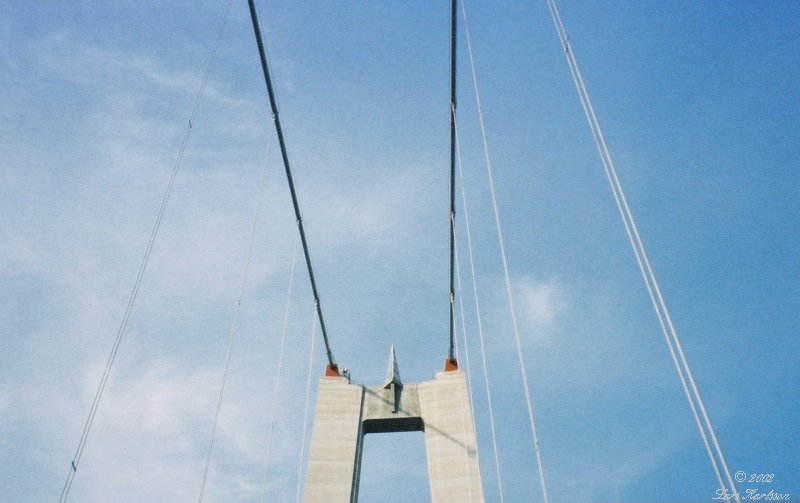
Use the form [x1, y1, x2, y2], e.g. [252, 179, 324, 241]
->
[456, 115, 505, 503]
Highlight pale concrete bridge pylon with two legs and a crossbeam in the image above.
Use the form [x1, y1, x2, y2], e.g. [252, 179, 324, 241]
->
[304, 370, 484, 503]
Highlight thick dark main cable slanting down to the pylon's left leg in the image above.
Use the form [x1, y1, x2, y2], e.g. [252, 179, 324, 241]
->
[248, 0, 338, 373]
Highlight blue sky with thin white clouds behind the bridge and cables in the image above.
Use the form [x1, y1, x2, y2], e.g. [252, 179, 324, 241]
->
[0, 0, 800, 502]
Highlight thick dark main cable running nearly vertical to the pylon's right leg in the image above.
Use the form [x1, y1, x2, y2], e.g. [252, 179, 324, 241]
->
[447, 0, 458, 368]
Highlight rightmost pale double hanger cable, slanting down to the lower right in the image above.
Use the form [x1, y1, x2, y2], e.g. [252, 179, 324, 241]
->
[547, 0, 739, 502]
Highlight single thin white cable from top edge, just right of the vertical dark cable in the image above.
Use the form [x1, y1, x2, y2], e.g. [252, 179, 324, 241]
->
[461, 0, 549, 503]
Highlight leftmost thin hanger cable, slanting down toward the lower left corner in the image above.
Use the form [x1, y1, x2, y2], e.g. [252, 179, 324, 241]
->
[58, 0, 232, 503]
